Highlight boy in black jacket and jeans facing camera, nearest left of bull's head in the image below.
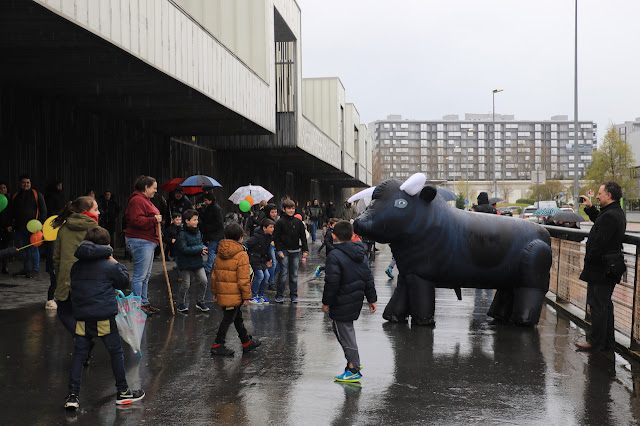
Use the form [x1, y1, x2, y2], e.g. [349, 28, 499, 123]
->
[273, 200, 309, 303]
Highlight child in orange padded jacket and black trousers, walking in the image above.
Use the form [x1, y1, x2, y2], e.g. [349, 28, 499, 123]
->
[211, 223, 262, 356]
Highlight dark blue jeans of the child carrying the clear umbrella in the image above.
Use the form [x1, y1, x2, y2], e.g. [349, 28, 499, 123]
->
[69, 329, 129, 395]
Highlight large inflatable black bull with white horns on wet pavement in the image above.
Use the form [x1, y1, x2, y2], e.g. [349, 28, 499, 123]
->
[350, 173, 551, 325]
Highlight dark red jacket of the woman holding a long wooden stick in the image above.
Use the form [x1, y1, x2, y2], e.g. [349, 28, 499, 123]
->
[124, 191, 160, 244]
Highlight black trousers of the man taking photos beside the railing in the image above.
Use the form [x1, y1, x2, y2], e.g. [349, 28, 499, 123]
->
[587, 282, 616, 350]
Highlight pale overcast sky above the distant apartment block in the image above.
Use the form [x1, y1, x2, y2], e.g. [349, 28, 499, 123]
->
[297, 0, 640, 141]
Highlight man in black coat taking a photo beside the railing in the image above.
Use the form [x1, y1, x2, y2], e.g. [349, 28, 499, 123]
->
[576, 181, 627, 350]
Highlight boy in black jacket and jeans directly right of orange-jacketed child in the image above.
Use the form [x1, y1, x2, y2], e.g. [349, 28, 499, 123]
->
[245, 219, 275, 305]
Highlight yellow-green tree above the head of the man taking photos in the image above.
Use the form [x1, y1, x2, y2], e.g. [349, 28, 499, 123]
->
[586, 124, 638, 199]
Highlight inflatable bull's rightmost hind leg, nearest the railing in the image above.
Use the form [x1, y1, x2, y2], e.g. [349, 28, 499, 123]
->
[509, 240, 552, 325]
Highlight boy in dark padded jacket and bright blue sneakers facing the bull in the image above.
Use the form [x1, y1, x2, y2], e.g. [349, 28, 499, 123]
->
[322, 220, 378, 382]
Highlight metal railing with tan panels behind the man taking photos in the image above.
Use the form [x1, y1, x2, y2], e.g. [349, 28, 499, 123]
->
[544, 225, 640, 351]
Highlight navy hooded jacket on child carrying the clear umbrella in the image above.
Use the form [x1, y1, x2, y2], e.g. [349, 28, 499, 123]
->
[71, 241, 129, 321]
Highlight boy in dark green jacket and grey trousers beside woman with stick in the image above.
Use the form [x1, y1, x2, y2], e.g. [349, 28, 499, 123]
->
[176, 209, 209, 312]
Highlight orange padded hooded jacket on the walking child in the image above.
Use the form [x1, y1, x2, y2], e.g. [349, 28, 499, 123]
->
[211, 240, 251, 307]
